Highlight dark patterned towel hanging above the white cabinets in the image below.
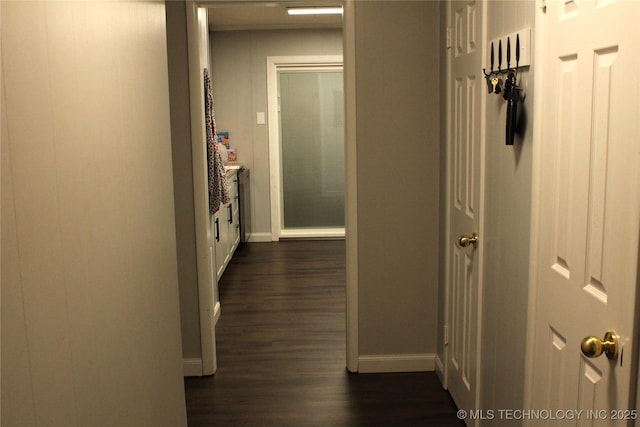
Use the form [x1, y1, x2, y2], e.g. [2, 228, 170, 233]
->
[204, 68, 231, 215]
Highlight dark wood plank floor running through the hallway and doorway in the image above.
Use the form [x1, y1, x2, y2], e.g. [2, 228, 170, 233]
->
[185, 241, 464, 427]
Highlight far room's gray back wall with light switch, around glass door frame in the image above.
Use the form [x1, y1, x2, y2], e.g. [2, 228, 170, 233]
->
[210, 30, 342, 241]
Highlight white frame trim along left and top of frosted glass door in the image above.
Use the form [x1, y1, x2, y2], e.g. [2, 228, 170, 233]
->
[267, 55, 344, 242]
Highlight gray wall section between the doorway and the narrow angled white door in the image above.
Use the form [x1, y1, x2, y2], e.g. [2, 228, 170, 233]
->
[348, 1, 441, 356]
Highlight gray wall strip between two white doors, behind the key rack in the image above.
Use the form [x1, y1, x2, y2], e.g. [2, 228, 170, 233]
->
[480, 1, 536, 414]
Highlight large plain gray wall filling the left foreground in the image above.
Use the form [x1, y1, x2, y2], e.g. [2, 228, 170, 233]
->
[1, 1, 186, 426]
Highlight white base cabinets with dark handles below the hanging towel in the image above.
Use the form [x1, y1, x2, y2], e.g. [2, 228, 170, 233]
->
[211, 169, 240, 279]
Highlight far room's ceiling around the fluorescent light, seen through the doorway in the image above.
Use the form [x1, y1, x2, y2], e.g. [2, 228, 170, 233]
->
[208, 0, 342, 31]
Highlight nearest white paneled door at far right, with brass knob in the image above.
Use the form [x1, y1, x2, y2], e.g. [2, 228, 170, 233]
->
[530, 0, 640, 416]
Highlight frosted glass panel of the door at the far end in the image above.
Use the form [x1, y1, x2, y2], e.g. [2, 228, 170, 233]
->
[278, 70, 344, 229]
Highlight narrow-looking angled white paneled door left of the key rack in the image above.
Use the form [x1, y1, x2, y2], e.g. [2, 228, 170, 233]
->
[446, 1, 485, 420]
